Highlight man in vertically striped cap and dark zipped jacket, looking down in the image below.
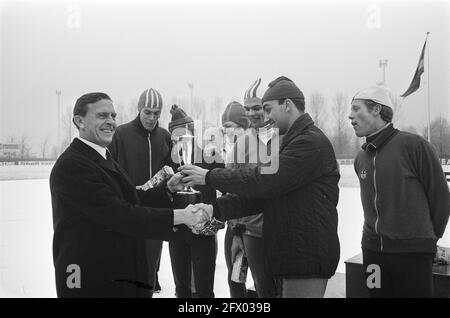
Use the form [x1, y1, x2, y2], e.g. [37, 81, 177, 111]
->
[109, 88, 172, 292]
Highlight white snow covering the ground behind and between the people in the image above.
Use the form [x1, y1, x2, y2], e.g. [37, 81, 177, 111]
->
[0, 165, 450, 298]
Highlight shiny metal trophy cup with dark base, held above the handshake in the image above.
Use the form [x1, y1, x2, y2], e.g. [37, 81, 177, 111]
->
[173, 130, 202, 209]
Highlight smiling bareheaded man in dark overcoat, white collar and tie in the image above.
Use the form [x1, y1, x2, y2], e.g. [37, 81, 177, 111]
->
[50, 93, 207, 297]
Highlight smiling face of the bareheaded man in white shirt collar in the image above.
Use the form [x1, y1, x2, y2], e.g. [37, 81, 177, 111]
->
[74, 99, 116, 147]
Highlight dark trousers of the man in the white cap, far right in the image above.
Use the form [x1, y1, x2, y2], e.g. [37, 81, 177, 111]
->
[363, 249, 434, 298]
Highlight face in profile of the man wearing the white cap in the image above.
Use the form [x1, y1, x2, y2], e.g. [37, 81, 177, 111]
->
[348, 99, 383, 137]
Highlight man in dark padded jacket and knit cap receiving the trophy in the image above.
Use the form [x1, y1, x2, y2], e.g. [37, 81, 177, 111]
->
[182, 77, 340, 298]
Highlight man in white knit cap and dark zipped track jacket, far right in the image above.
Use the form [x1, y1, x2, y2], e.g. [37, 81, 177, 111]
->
[349, 86, 450, 297]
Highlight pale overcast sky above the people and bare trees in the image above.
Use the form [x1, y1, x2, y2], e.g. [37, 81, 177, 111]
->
[0, 0, 450, 150]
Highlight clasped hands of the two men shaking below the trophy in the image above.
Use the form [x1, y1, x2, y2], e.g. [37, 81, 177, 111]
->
[174, 203, 225, 235]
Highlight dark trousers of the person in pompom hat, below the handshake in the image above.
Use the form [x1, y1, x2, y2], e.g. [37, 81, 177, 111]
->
[169, 228, 217, 298]
